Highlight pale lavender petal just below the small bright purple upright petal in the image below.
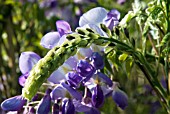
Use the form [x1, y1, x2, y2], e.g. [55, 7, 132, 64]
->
[40, 32, 60, 49]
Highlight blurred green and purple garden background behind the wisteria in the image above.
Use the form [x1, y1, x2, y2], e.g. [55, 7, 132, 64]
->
[0, 0, 164, 114]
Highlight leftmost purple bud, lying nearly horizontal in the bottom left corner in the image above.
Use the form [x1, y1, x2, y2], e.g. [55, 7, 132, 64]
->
[1, 95, 27, 111]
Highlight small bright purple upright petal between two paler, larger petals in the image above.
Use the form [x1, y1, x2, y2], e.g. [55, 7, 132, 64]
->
[56, 20, 71, 36]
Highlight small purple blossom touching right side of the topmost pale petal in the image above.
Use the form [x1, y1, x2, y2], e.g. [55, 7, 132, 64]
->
[103, 9, 120, 30]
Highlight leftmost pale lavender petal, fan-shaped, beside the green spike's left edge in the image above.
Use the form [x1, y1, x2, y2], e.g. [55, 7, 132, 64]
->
[19, 52, 41, 74]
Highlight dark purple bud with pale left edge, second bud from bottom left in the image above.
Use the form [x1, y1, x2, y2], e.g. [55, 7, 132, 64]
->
[37, 89, 51, 114]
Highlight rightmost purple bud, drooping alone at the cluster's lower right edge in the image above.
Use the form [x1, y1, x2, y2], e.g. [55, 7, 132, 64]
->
[112, 89, 128, 110]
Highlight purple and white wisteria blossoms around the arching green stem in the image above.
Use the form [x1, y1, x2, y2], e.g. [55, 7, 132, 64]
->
[1, 7, 128, 114]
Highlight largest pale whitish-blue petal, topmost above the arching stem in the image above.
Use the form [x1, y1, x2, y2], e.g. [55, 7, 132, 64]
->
[79, 7, 107, 26]
